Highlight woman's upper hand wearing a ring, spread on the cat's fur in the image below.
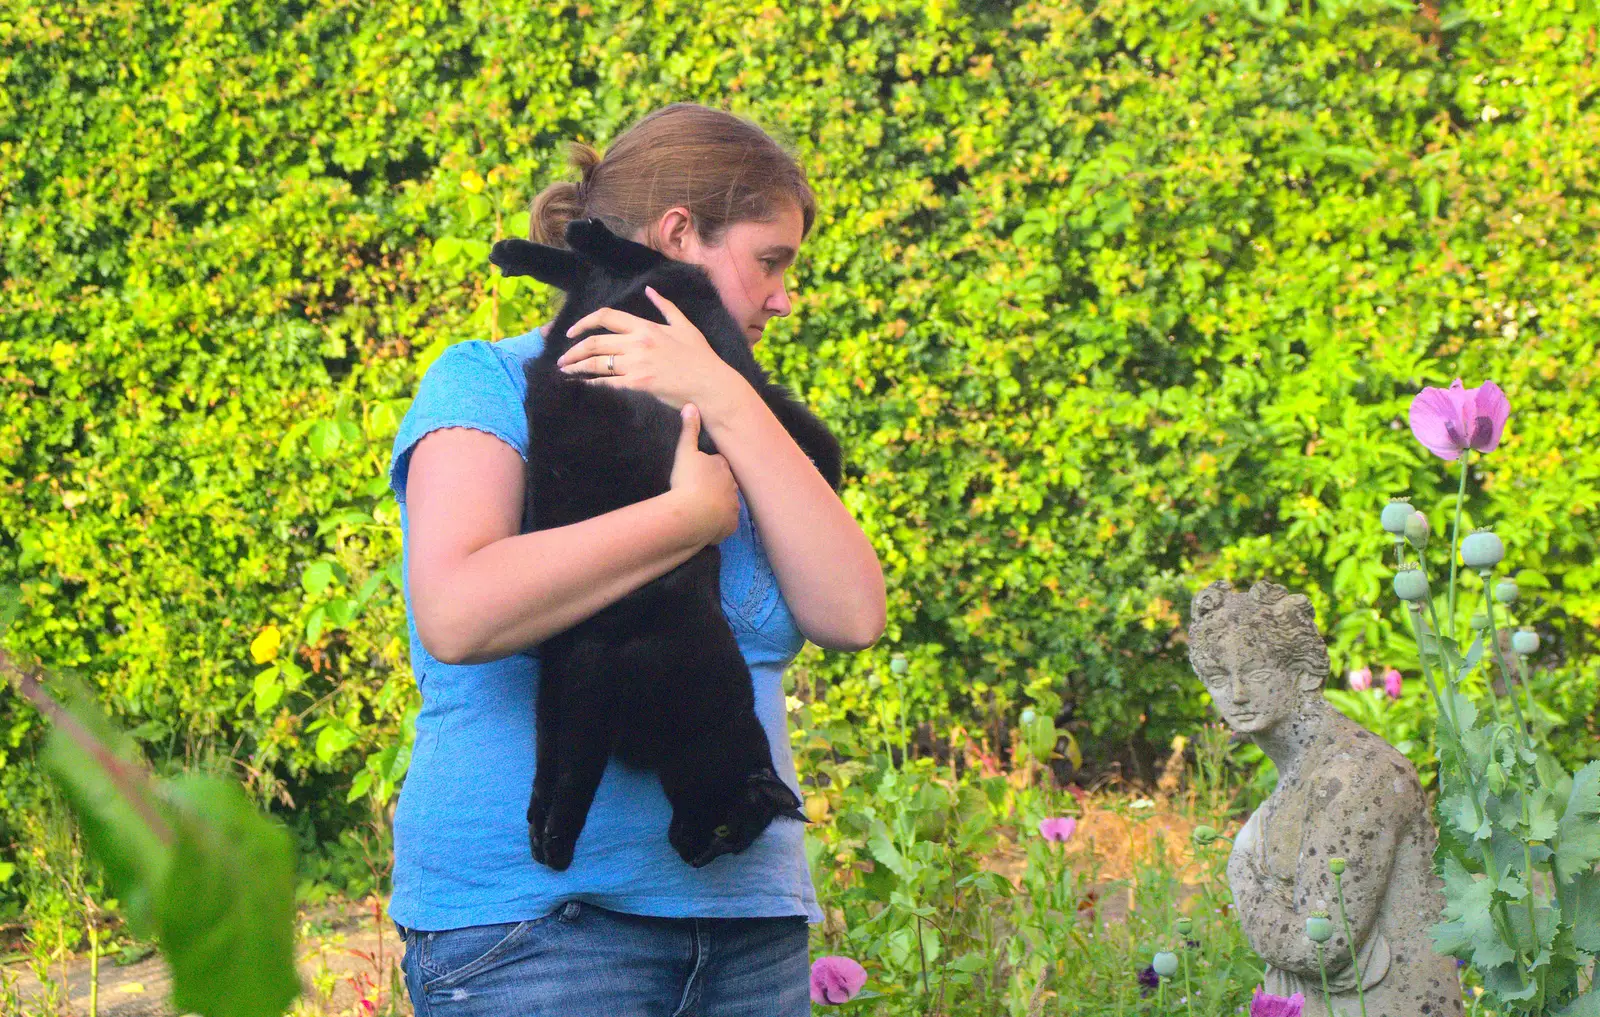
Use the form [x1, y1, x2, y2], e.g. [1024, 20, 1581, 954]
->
[555, 286, 738, 416]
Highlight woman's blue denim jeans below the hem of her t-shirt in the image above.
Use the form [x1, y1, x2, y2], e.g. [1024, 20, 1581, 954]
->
[400, 900, 811, 1017]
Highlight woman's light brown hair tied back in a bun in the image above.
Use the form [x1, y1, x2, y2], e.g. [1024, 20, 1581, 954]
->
[528, 102, 816, 246]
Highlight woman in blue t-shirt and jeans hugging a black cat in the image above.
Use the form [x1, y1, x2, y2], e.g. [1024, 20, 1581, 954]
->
[390, 104, 885, 1017]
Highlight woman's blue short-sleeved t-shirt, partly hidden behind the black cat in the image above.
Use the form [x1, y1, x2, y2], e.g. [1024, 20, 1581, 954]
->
[380, 331, 822, 931]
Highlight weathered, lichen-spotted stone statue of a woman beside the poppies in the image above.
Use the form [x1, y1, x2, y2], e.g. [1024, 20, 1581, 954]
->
[1189, 582, 1462, 1017]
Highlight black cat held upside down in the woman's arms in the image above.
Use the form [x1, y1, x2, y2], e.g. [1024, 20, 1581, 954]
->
[490, 219, 840, 870]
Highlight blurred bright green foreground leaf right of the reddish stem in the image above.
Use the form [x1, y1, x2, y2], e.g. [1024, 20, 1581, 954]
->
[155, 776, 299, 1017]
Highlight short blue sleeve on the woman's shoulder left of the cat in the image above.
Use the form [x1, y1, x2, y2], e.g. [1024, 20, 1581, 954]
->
[389, 339, 528, 502]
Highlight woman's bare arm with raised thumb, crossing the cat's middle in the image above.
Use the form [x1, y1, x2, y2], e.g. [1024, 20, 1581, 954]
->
[406, 406, 739, 664]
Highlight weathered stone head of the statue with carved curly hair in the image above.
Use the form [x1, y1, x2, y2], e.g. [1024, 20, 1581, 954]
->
[1189, 580, 1328, 734]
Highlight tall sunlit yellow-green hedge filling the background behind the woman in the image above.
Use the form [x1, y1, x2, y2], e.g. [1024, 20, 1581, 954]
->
[0, 0, 1600, 921]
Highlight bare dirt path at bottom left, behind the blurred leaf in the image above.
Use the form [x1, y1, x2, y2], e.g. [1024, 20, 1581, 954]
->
[0, 903, 411, 1017]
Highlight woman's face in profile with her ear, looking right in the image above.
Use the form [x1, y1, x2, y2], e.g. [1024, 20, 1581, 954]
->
[662, 201, 805, 345]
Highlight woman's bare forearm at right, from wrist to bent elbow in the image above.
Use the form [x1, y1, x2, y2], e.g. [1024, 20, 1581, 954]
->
[706, 380, 886, 649]
